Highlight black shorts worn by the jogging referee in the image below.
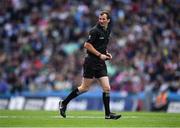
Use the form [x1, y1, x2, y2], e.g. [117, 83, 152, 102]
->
[83, 58, 107, 78]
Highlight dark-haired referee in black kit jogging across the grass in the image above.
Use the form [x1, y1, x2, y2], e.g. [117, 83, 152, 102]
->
[59, 11, 121, 120]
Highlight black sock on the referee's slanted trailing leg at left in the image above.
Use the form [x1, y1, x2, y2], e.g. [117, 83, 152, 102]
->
[62, 88, 82, 106]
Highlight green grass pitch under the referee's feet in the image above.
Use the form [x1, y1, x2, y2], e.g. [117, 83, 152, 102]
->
[0, 110, 180, 128]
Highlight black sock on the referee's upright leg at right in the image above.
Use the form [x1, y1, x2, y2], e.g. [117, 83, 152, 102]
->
[103, 92, 110, 115]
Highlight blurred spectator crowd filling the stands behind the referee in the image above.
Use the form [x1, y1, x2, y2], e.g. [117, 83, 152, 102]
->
[0, 0, 180, 97]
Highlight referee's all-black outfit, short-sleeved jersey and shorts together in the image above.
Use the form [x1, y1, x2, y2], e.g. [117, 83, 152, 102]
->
[83, 24, 110, 78]
